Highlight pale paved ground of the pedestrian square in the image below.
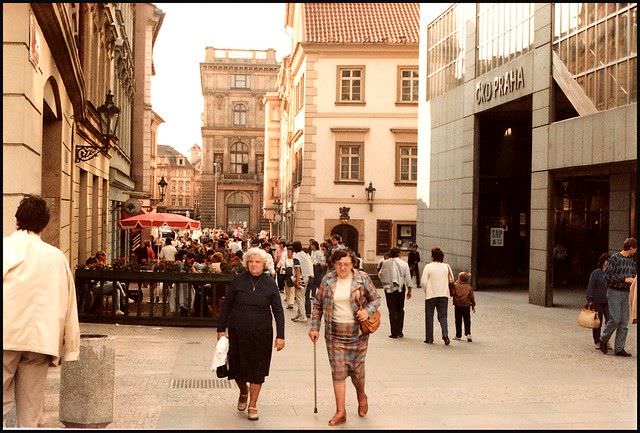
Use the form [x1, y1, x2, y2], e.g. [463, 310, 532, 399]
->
[15, 290, 637, 429]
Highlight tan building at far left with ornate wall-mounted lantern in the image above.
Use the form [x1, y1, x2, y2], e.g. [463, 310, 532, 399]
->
[2, 3, 138, 267]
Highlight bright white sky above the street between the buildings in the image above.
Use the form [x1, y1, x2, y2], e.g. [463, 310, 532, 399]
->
[151, 3, 448, 156]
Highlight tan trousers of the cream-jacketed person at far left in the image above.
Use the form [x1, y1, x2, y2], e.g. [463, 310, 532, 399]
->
[2, 350, 51, 427]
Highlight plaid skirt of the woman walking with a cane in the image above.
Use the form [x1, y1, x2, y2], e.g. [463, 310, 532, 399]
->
[326, 321, 369, 381]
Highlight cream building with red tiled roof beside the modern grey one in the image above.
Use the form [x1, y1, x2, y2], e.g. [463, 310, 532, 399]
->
[264, 3, 419, 264]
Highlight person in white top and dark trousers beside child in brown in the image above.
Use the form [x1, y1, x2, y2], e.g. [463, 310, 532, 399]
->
[420, 247, 454, 345]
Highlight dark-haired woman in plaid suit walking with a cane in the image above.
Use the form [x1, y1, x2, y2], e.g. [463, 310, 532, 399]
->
[309, 250, 380, 426]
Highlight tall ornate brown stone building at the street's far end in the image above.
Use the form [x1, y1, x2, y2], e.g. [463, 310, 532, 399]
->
[200, 47, 278, 232]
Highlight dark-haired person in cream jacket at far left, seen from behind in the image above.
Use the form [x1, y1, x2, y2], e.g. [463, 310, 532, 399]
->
[2, 195, 80, 428]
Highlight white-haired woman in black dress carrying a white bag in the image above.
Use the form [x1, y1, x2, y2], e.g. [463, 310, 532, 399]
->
[218, 248, 285, 421]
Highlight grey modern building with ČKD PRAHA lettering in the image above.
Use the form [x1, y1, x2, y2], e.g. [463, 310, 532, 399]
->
[418, 3, 637, 306]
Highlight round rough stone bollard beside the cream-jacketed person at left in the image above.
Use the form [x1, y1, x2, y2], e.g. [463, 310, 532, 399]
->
[59, 334, 116, 428]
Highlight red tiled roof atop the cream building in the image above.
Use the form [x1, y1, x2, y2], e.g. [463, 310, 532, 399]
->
[304, 3, 420, 44]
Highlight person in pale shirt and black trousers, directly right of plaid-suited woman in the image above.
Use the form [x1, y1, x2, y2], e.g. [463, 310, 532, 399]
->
[378, 248, 415, 338]
